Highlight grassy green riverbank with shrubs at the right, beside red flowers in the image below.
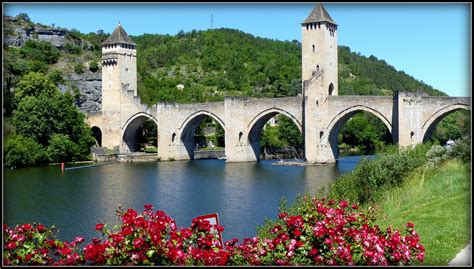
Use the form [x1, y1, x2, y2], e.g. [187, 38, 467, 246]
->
[257, 137, 471, 265]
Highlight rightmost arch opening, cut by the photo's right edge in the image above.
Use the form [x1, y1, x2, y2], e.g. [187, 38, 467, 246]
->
[423, 107, 471, 145]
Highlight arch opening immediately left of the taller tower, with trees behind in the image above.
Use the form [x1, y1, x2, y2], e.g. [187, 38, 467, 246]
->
[248, 111, 304, 161]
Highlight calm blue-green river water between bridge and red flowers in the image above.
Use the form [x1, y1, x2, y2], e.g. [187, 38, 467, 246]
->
[3, 156, 366, 241]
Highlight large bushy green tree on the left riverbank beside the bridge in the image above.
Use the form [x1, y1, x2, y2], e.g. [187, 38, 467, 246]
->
[4, 73, 94, 165]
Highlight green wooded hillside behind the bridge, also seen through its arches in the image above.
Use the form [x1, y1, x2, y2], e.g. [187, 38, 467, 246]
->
[3, 14, 470, 166]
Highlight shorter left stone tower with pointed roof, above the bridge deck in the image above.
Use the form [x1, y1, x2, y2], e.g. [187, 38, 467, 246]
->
[102, 23, 137, 111]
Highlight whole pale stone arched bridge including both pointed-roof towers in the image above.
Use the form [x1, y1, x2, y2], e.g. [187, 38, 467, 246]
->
[87, 4, 471, 163]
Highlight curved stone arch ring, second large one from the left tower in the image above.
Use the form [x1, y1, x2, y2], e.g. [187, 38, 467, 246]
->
[179, 110, 225, 160]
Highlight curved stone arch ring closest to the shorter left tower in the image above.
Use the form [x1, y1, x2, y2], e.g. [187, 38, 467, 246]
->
[121, 112, 158, 152]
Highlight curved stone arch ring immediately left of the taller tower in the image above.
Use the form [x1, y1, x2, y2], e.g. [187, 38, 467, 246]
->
[247, 107, 303, 161]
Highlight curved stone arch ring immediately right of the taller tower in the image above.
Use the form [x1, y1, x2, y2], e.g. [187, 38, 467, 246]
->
[319, 105, 393, 159]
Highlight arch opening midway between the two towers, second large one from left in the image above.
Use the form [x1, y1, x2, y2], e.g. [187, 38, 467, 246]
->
[181, 114, 225, 160]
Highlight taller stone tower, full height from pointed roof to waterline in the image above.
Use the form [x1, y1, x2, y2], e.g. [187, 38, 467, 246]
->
[301, 4, 338, 163]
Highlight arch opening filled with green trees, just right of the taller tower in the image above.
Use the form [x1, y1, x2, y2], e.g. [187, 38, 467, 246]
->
[327, 109, 393, 161]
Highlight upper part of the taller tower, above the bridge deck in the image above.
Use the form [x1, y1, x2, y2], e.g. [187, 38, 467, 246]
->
[301, 3, 338, 98]
